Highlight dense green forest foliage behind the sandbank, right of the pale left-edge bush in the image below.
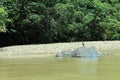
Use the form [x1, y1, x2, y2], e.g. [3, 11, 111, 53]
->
[0, 0, 120, 46]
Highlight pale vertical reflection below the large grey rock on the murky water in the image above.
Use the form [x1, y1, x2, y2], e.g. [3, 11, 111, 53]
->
[75, 58, 99, 80]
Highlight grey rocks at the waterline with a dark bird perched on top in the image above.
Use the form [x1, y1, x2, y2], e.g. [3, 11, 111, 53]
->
[56, 47, 99, 58]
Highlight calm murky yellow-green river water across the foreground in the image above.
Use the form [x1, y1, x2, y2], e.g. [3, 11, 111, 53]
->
[0, 56, 120, 80]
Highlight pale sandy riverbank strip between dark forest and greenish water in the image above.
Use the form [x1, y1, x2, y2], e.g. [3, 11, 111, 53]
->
[0, 41, 120, 58]
